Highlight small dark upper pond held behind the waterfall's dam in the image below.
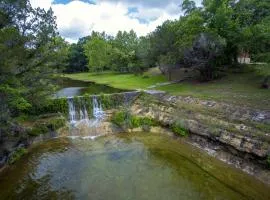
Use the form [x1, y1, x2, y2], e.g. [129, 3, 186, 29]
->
[55, 78, 126, 97]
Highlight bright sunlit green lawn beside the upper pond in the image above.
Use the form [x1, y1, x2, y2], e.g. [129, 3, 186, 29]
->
[64, 72, 167, 90]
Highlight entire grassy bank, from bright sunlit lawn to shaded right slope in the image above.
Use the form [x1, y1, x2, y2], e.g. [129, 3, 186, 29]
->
[65, 65, 270, 109]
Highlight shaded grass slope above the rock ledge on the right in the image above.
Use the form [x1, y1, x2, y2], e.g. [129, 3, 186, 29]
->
[156, 65, 270, 110]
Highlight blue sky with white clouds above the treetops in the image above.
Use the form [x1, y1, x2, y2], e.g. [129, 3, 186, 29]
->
[30, 0, 201, 43]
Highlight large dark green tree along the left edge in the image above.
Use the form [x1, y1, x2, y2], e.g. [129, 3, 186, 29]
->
[0, 0, 64, 124]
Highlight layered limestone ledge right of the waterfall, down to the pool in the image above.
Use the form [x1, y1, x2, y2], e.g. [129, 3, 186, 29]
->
[128, 94, 270, 184]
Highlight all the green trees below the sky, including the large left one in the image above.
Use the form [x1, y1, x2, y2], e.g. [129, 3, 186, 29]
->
[0, 0, 270, 130]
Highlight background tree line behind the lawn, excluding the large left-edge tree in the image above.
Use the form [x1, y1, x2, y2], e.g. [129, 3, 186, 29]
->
[66, 0, 270, 80]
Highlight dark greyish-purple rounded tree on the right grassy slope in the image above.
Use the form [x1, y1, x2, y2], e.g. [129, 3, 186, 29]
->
[184, 34, 226, 81]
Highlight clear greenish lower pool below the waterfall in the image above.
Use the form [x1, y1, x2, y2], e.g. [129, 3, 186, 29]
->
[0, 133, 270, 200]
